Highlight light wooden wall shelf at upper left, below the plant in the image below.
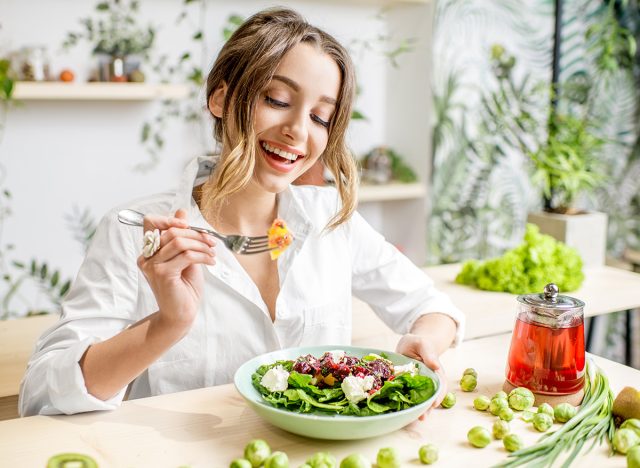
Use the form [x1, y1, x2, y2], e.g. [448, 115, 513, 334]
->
[13, 81, 189, 101]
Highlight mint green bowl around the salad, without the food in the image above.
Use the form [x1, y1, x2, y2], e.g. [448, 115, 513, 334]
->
[233, 345, 440, 440]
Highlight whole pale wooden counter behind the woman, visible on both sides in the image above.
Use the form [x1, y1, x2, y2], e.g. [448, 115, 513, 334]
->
[5, 264, 640, 397]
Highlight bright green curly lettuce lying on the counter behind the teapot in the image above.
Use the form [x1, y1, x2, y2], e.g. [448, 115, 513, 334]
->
[456, 224, 584, 294]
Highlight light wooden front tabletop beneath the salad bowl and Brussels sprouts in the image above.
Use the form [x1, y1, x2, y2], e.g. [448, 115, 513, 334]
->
[0, 334, 640, 468]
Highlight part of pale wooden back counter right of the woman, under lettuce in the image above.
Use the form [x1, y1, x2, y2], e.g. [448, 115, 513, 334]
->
[353, 264, 640, 340]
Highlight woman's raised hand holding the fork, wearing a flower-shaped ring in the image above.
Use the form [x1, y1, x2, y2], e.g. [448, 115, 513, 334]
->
[138, 210, 215, 333]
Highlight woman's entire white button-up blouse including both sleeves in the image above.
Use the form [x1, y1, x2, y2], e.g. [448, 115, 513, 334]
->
[19, 157, 464, 416]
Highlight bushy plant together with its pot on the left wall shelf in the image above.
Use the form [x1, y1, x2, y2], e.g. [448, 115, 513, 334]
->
[63, 0, 155, 82]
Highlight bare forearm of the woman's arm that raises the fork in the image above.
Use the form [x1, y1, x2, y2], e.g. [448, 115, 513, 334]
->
[80, 312, 185, 400]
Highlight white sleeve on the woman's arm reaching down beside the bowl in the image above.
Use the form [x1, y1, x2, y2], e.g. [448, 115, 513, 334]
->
[348, 213, 465, 346]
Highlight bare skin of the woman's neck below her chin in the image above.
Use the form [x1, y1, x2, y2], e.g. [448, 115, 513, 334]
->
[215, 182, 278, 236]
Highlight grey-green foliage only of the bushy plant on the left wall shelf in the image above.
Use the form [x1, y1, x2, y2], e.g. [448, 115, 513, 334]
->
[63, 0, 156, 58]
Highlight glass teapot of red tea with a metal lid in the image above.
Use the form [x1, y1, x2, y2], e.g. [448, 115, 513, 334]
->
[506, 283, 585, 395]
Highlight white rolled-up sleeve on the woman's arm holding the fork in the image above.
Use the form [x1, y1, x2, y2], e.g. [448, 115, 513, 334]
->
[18, 212, 139, 416]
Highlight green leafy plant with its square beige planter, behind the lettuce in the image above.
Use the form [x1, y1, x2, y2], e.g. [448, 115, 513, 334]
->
[484, 45, 607, 265]
